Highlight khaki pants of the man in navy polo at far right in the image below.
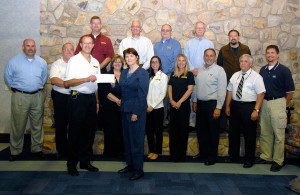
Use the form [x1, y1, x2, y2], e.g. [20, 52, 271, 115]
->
[260, 98, 287, 165]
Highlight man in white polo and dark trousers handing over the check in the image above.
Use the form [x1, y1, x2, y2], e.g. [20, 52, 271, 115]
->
[64, 35, 100, 176]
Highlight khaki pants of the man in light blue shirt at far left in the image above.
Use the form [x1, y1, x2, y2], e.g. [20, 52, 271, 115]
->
[10, 91, 45, 155]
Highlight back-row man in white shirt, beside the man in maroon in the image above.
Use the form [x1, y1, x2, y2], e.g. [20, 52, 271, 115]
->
[119, 19, 154, 70]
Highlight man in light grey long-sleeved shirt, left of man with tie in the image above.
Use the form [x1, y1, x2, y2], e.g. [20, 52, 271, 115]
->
[193, 48, 227, 166]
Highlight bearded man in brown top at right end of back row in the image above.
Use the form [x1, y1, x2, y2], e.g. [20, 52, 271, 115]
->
[217, 29, 251, 131]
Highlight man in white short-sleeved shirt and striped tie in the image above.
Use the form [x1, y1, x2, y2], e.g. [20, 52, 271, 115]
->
[226, 54, 266, 168]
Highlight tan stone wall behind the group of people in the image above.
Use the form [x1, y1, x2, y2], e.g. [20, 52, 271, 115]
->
[40, 0, 300, 125]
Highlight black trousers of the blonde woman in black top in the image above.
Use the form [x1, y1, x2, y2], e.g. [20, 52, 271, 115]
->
[169, 100, 191, 162]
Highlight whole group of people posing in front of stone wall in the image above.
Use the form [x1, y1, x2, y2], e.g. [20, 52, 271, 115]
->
[5, 16, 295, 180]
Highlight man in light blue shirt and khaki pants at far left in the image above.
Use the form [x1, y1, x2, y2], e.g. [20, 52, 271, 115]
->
[4, 39, 48, 161]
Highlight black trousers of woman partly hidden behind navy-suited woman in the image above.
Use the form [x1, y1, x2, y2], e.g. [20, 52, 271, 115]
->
[102, 107, 124, 157]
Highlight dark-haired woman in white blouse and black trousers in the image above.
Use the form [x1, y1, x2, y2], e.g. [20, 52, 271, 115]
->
[146, 56, 168, 160]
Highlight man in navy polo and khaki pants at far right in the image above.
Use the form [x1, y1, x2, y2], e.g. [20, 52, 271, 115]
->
[256, 45, 295, 172]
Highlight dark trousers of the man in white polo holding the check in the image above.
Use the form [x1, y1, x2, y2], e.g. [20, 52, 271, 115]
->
[67, 94, 96, 168]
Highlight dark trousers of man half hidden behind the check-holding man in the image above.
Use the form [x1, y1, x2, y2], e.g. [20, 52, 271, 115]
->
[51, 90, 70, 155]
